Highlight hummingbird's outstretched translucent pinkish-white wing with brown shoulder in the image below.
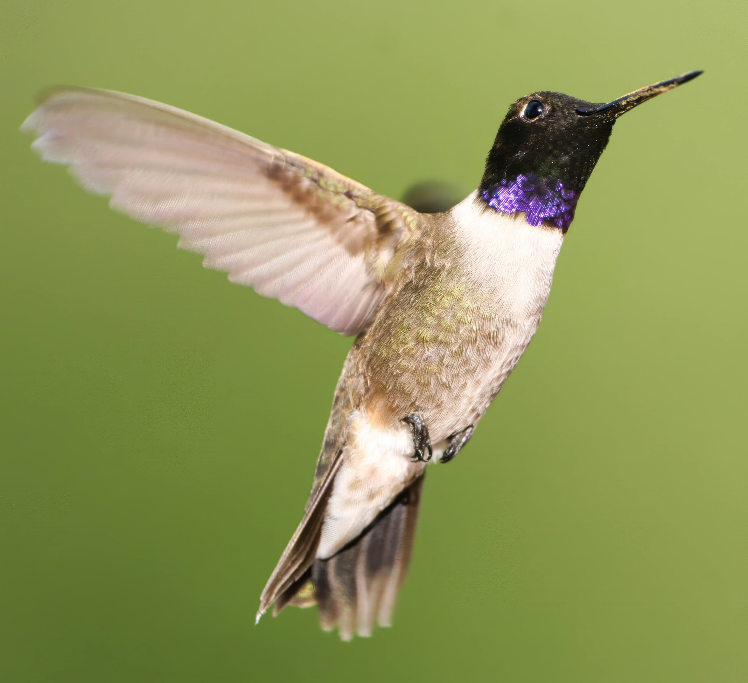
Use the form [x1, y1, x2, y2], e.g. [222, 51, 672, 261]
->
[22, 88, 422, 334]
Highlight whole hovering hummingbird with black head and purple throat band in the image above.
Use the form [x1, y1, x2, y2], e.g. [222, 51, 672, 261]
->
[22, 71, 702, 640]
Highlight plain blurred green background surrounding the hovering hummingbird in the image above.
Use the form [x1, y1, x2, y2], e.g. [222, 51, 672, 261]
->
[0, 0, 748, 683]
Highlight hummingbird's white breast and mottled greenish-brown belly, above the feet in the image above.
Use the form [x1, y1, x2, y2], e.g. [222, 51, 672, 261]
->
[357, 202, 563, 442]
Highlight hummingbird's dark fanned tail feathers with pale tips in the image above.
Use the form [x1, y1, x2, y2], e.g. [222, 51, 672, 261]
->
[257, 470, 424, 640]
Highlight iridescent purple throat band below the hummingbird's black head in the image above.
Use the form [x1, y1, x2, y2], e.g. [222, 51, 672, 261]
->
[482, 173, 579, 232]
